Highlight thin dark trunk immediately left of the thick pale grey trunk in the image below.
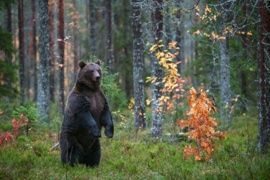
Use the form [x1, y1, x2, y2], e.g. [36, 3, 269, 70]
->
[32, 0, 38, 101]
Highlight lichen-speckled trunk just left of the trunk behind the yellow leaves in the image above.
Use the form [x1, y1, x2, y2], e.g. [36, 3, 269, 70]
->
[132, 0, 146, 130]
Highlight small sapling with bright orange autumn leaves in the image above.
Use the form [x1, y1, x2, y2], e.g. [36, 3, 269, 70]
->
[177, 88, 226, 161]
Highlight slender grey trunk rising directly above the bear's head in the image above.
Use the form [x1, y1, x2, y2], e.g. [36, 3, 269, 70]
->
[89, 0, 96, 61]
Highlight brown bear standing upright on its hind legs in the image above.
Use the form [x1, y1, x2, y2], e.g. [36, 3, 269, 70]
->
[60, 60, 114, 167]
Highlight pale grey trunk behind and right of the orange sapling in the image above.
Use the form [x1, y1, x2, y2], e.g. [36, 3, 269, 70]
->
[219, 0, 231, 121]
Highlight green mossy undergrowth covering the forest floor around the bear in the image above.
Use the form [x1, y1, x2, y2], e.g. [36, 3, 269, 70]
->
[0, 112, 270, 179]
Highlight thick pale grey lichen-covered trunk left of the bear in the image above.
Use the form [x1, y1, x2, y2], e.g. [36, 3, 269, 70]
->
[37, 0, 50, 123]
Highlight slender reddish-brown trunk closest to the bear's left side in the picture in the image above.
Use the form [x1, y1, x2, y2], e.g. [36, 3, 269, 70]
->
[58, 0, 65, 114]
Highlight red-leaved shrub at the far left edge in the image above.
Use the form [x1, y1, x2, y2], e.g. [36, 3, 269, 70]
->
[0, 114, 28, 150]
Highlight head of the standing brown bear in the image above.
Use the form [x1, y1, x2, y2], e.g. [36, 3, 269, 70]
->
[76, 60, 102, 90]
